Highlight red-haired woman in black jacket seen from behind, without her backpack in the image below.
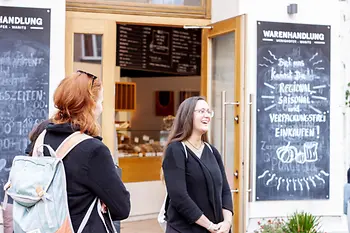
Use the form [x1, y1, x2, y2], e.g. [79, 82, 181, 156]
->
[44, 71, 130, 233]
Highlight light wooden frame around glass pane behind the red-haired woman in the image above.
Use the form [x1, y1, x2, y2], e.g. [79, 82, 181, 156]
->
[65, 17, 116, 157]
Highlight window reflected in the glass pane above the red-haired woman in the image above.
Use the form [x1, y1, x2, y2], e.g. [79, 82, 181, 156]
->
[81, 34, 102, 61]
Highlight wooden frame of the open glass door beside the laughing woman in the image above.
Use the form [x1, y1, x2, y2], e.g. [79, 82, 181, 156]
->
[201, 15, 245, 233]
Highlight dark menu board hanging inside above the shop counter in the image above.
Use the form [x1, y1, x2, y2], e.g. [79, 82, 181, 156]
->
[117, 25, 202, 75]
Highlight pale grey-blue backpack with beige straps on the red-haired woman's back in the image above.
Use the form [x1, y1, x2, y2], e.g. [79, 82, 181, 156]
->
[3, 130, 116, 233]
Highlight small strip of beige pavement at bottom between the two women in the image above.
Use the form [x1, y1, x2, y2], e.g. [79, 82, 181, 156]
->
[120, 219, 163, 233]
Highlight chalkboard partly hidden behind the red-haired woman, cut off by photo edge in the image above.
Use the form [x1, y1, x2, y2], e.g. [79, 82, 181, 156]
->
[0, 7, 51, 200]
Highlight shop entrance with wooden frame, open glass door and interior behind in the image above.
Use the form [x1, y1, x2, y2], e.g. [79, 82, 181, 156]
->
[66, 12, 243, 232]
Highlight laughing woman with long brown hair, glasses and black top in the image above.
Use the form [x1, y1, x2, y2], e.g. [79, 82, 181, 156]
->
[162, 97, 233, 233]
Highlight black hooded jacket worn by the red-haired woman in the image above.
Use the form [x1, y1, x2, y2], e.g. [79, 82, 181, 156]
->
[44, 124, 130, 233]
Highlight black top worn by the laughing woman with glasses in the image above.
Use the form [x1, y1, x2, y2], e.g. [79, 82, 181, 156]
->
[162, 142, 233, 233]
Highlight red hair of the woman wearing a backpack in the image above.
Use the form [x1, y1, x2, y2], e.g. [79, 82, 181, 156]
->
[53, 72, 102, 136]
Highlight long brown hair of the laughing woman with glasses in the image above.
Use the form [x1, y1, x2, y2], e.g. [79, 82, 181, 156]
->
[161, 96, 208, 179]
